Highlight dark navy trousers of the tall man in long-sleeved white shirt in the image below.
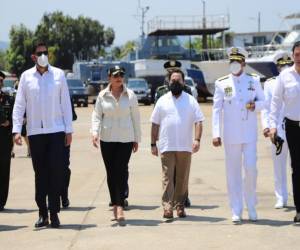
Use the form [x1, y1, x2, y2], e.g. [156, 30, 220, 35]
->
[28, 132, 65, 216]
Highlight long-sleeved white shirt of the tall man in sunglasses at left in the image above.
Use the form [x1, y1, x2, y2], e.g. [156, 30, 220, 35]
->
[13, 65, 73, 136]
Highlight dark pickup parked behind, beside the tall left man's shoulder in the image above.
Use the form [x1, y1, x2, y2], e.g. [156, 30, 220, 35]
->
[67, 79, 88, 107]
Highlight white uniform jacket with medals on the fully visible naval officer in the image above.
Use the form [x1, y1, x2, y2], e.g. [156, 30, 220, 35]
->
[212, 73, 265, 144]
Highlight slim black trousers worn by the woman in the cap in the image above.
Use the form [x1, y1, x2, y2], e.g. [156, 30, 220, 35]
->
[100, 141, 133, 206]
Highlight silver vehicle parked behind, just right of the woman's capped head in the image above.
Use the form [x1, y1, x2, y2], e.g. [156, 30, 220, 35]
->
[127, 78, 151, 105]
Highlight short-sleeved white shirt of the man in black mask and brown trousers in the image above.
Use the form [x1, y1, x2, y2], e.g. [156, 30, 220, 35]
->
[150, 92, 204, 153]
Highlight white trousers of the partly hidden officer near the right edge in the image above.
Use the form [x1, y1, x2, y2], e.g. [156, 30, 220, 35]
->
[272, 140, 288, 204]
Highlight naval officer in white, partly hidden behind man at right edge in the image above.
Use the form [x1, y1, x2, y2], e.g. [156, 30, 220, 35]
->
[261, 51, 293, 209]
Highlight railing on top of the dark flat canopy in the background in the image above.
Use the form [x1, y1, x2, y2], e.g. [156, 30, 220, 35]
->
[148, 15, 229, 34]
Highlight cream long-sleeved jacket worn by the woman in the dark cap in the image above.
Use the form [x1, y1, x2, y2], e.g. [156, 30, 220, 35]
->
[92, 85, 141, 143]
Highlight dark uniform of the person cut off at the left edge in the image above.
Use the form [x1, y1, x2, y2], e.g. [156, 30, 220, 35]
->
[0, 87, 14, 210]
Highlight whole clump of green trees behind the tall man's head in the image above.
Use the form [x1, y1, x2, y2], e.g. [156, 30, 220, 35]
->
[7, 11, 115, 73]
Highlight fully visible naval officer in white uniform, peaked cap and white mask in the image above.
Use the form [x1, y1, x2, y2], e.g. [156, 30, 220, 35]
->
[212, 47, 265, 223]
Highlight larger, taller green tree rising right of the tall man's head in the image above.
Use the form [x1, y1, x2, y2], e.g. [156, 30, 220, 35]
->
[35, 11, 115, 69]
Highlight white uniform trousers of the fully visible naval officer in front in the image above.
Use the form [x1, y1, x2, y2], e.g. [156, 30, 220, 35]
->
[224, 141, 257, 216]
